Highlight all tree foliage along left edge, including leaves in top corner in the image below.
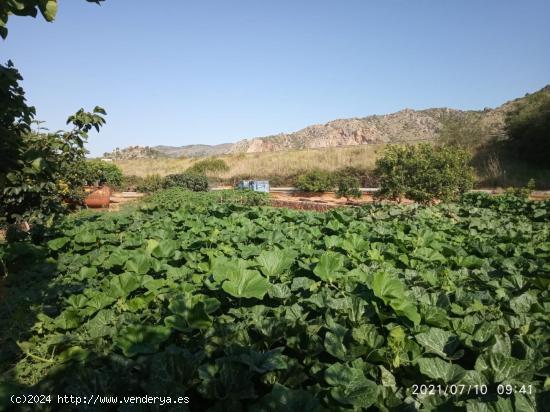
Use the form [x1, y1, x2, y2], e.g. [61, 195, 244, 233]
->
[0, 0, 106, 232]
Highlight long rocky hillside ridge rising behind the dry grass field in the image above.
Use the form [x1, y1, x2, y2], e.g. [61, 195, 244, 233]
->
[105, 86, 550, 157]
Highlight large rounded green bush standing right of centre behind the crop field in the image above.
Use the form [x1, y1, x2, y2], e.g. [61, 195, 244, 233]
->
[375, 143, 474, 203]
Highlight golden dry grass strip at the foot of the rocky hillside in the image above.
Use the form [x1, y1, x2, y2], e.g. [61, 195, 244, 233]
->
[116, 144, 384, 179]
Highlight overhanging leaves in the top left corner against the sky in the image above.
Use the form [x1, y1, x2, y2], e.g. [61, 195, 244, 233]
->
[0, 0, 104, 39]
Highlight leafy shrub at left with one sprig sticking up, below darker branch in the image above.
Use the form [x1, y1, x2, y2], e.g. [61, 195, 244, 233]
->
[0, 107, 105, 226]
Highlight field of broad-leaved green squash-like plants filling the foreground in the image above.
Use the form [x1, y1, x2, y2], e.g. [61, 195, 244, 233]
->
[0, 189, 550, 412]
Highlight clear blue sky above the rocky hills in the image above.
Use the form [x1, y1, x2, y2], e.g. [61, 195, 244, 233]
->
[0, 0, 550, 155]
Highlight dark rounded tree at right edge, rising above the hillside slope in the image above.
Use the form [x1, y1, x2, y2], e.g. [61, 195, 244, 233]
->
[506, 87, 550, 168]
